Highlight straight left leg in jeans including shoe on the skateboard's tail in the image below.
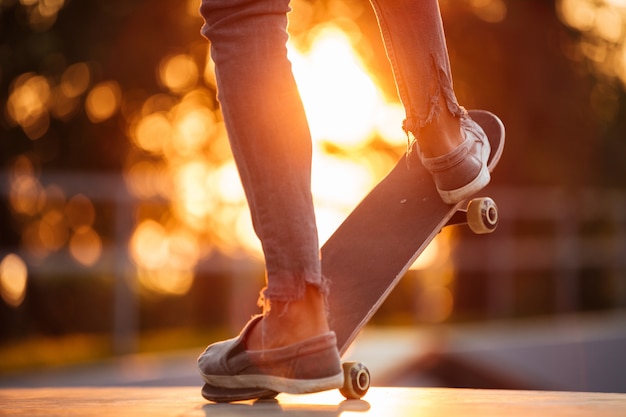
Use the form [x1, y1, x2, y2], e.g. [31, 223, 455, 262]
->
[199, 0, 341, 392]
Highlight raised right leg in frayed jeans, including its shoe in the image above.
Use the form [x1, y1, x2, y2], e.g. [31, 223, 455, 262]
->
[371, 0, 489, 203]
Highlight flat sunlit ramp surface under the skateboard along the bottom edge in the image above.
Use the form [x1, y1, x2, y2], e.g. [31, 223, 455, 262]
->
[0, 387, 626, 417]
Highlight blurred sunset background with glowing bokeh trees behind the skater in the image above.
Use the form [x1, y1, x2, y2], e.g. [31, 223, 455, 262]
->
[0, 0, 626, 392]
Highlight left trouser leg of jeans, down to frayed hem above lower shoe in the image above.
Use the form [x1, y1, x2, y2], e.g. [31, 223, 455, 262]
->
[201, 0, 326, 344]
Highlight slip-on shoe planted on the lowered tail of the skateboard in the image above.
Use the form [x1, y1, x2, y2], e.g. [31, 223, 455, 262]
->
[198, 316, 343, 394]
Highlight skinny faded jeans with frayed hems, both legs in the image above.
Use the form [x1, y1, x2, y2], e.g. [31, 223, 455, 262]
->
[200, 0, 463, 302]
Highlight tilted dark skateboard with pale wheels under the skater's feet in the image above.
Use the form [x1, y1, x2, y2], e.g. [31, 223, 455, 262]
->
[202, 110, 505, 402]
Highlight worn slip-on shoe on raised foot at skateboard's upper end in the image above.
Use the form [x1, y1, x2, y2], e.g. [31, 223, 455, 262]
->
[420, 116, 491, 204]
